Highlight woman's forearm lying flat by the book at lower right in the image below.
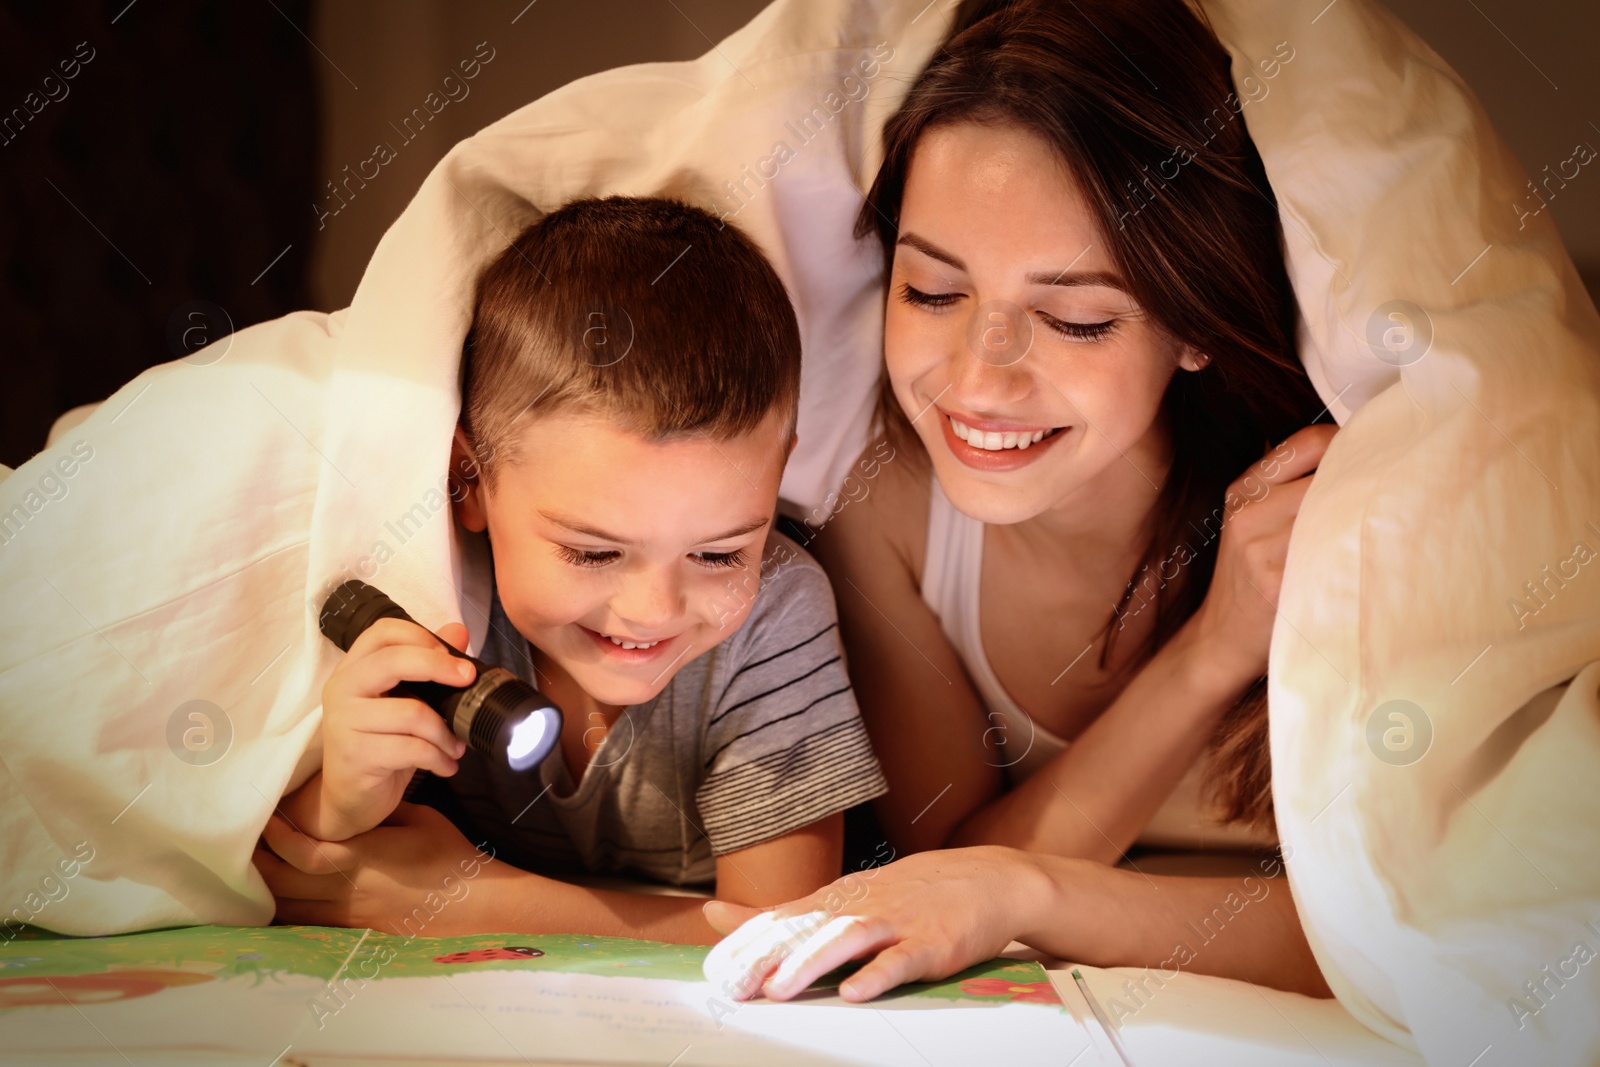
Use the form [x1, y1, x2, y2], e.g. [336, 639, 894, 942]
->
[1016, 854, 1333, 997]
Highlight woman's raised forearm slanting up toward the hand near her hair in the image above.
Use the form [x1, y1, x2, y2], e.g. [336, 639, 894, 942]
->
[949, 627, 1248, 862]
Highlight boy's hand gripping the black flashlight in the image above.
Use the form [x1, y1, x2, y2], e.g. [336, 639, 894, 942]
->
[316, 619, 477, 840]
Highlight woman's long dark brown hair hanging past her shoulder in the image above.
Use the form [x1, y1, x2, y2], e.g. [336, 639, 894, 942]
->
[856, 0, 1323, 824]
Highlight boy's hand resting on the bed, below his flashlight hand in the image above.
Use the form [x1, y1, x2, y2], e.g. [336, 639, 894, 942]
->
[253, 803, 494, 937]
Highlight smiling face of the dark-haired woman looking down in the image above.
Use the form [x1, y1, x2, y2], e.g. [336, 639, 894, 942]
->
[883, 123, 1200, 523]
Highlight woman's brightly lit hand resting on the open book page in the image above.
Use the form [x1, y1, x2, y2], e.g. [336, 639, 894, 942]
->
[706, 846, 1048, 1001]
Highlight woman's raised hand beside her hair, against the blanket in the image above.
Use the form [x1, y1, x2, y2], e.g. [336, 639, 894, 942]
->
[1186, 424, 1338, 691]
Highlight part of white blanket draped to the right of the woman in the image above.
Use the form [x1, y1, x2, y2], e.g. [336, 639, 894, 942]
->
[1206, 0, 1600, 1067]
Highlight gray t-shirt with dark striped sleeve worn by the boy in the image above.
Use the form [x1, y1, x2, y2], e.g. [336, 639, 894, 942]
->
[429, 531, 888, 885]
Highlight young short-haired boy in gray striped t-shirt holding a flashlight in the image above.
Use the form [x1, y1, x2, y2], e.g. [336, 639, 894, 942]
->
[269, 197, 886, 941]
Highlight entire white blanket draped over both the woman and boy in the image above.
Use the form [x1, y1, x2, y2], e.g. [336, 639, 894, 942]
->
[0, 0, 1600, 1067]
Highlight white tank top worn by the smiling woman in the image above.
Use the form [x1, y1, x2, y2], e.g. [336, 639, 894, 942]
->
[922, 478, 1277, 848]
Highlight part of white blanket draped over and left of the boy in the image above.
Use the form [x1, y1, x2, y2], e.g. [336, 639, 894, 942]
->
[0, 0, 944, 934]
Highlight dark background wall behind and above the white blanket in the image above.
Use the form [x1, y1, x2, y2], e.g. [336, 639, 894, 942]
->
[0, 0, 1600, 467]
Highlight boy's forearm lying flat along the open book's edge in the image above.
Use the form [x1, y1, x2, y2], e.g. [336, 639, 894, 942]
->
[472, 864, 717, 945]
